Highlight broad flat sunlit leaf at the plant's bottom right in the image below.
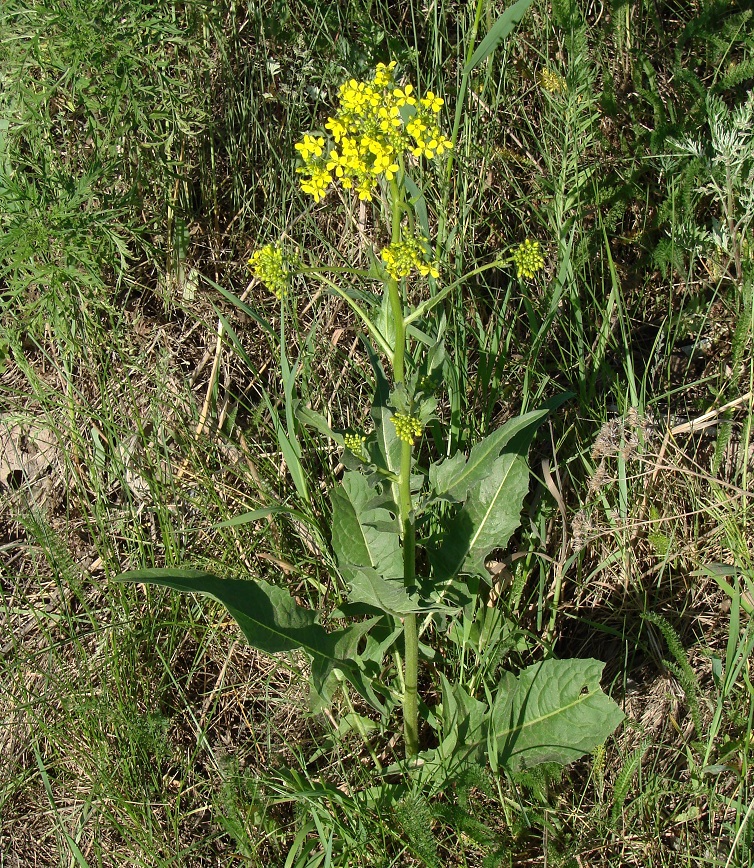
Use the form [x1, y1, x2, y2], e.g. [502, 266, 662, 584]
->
[490, 660, 625, 772]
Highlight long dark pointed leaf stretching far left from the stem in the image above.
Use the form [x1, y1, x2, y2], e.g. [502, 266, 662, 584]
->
[115, 569, 382, 710]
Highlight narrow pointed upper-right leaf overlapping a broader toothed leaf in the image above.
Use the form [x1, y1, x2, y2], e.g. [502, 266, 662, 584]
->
[429, 410, 548, 501]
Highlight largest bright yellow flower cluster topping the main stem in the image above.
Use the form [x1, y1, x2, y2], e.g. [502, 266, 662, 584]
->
[295, 61, 452, 202]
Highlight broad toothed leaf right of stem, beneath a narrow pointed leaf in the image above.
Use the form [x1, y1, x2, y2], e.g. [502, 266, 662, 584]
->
[427, 453, 529, 582]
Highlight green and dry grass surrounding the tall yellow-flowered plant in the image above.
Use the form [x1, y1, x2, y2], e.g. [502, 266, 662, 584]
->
[0, 0, 754, 868]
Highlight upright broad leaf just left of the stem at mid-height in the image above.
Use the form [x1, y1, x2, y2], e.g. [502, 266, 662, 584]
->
[332, 472, 403, 584]
